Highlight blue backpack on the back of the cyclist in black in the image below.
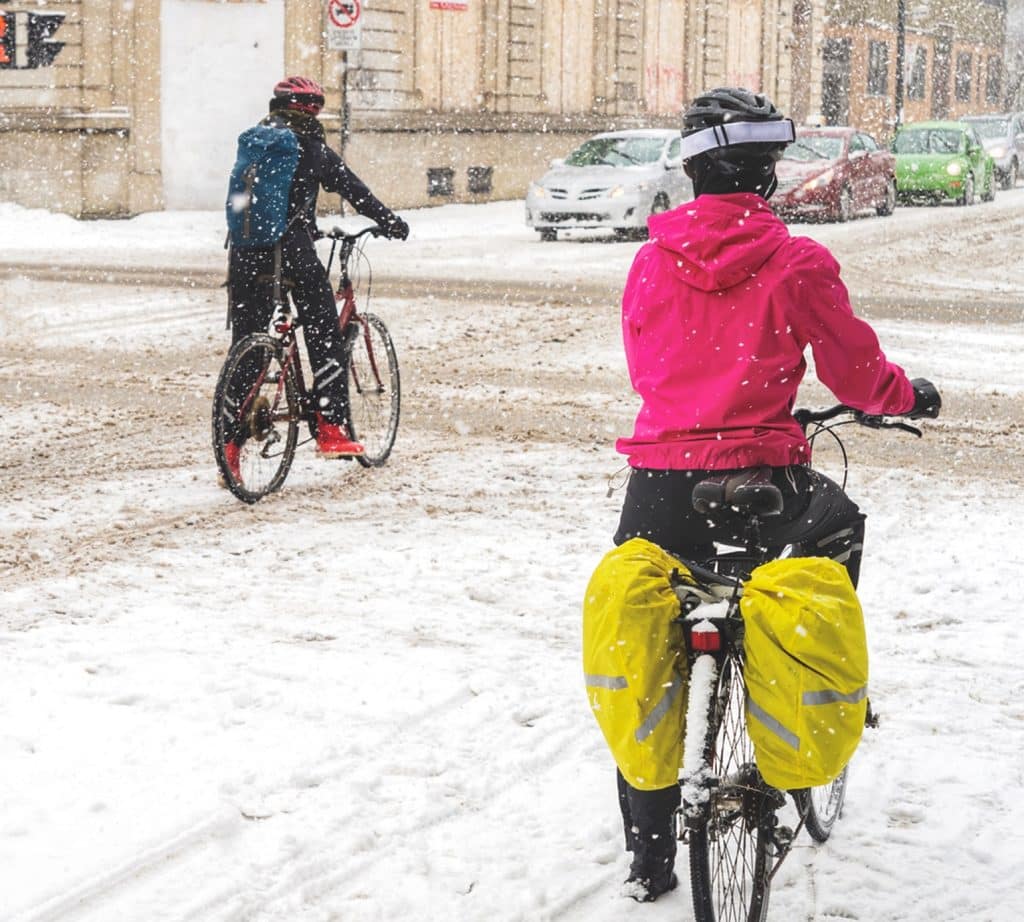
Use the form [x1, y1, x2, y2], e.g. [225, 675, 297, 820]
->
[224, 125, 299, 249]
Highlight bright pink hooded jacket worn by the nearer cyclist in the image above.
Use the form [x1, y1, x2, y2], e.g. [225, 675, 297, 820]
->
[615, 193, 913, 470]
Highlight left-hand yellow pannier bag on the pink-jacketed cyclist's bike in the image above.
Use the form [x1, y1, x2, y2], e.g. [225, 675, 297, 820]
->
[583, 538, 688, 791]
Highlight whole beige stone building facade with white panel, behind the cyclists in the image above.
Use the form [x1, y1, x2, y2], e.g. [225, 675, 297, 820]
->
[0, 0, 825, 216]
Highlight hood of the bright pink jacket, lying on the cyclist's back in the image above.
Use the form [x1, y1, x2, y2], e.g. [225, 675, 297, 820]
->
[648, 193, 790, 292]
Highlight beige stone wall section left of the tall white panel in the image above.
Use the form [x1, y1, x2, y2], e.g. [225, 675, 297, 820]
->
[0, 0, 163, 215]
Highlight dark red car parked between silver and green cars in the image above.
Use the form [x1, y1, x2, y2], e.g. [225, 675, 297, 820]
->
[771, 128, 896, 221]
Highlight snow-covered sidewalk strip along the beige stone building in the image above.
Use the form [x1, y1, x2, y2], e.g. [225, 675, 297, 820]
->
[0, 202, 638, 297]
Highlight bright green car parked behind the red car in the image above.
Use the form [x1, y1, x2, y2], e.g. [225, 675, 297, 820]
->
[892, 122, 995, 205]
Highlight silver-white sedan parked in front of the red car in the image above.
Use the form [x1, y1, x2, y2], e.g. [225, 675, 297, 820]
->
[526, 129, 693, 240]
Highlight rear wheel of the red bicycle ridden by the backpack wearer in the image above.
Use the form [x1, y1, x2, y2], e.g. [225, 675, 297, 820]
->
[213, 333, 301, 504]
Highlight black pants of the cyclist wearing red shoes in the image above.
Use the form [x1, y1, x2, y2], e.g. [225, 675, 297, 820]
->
[227, 227, 348, 424]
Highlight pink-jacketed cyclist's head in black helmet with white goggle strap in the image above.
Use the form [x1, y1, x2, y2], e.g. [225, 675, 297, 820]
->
[682, 87, 796, 198]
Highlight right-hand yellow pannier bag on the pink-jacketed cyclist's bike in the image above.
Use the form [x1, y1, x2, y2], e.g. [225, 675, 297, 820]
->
[740, 557, 867, 790]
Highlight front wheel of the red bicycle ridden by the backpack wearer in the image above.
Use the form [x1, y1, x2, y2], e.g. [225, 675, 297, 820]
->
[345, 313, 401, 467]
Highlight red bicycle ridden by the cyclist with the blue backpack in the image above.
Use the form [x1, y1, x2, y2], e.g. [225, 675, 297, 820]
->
[213, 224, 401, 503]
